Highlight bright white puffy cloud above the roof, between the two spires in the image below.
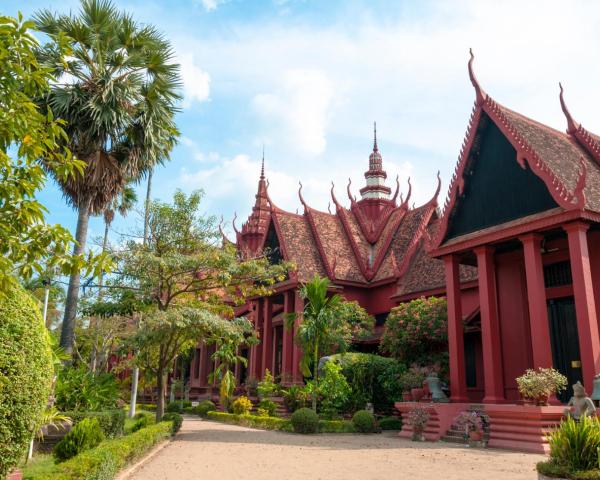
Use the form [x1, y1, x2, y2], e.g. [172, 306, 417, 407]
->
[252, 69, 333, 155]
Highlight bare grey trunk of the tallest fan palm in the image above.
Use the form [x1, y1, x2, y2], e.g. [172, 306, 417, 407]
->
[60, 205, 90, 355]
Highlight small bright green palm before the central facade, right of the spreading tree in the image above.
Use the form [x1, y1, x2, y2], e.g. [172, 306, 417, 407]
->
[287, 275, 346, 412]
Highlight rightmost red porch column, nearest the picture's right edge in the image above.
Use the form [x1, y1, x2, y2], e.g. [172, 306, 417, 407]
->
[563, 222, 600, 392]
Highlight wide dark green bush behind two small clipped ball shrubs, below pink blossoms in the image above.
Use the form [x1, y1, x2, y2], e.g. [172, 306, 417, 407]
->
[331, 352, 406, 413]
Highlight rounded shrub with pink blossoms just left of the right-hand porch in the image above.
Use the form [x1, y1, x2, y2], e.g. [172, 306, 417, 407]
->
[380, 297, 448, 365]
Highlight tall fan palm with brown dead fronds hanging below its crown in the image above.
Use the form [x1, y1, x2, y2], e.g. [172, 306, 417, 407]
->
[34, 0, 181, 353]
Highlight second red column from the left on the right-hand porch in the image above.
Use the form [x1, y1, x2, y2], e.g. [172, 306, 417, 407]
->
[475, 245, 505, 403]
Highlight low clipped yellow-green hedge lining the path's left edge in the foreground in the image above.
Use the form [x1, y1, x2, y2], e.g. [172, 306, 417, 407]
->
[32, 422, 173, 480]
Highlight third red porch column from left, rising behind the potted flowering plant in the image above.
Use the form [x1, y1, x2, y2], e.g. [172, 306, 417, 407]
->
[519, 233, 552, 368]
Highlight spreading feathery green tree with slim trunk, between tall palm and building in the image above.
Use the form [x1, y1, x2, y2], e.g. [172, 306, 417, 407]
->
[113, 192, 289, 418]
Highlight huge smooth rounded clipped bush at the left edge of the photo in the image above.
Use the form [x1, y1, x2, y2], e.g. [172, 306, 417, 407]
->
[0, 285, 52, 478]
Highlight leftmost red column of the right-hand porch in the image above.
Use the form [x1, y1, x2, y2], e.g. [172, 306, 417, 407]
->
[444, 255, 469, 402]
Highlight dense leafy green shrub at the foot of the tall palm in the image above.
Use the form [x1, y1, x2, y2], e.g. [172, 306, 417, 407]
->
[55, 366, 119, 411]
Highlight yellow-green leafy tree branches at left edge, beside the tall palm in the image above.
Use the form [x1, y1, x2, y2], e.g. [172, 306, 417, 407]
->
[0, 16, 91, 295]
